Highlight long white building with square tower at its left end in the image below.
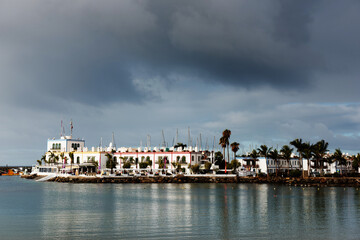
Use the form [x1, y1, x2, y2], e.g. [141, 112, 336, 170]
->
[33, 136, 213, 175]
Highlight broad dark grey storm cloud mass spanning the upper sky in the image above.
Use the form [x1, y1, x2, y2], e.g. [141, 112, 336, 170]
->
[0, 0, 359, 108]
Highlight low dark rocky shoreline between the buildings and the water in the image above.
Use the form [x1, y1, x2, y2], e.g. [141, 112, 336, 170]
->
[22, 175, 360, 187]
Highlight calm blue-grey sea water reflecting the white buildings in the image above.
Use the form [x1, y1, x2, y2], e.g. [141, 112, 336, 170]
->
[0, 176, 360, 239]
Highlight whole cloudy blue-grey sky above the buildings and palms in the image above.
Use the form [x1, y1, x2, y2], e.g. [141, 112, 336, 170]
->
[0, 0, 360, 166]
